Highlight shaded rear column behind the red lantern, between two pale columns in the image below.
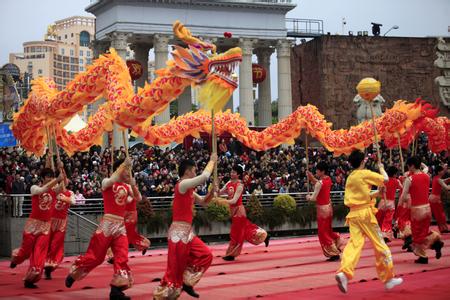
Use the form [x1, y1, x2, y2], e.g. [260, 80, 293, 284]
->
[256, 48, 274, 126]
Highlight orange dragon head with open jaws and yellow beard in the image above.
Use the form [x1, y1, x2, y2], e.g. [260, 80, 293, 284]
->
[168, 21, 242, 110]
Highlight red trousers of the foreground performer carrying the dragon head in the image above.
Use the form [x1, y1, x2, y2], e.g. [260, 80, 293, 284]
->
[153, 222, 212, 299]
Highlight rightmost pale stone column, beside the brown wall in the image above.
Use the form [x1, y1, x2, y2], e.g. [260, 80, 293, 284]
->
[277, 40, 292, 121]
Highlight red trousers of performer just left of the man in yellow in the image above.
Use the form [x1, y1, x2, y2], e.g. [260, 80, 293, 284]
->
[317, 204, 342, 257]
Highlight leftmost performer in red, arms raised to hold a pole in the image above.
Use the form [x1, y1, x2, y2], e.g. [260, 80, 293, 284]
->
[10, 168, 64, 288]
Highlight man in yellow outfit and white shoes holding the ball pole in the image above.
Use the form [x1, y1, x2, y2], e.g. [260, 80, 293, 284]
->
[336, 150, 403, 293]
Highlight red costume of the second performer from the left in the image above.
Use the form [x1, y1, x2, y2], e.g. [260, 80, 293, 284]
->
[45, 190, 75, 271]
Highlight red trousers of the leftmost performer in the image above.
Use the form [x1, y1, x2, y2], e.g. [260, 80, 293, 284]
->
[11, 219, 50, 283]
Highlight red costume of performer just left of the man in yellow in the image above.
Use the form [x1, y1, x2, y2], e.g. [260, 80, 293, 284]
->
[316, 176, 343, 257]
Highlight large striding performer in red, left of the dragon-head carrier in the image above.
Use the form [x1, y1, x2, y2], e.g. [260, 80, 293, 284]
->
[66, 158, 134, 299]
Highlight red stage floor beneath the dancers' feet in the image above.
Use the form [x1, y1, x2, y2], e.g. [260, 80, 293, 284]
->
[0, 234, 450, 300]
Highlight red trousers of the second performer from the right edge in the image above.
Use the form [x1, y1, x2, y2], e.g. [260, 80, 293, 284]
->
[411, 204, 440, 257]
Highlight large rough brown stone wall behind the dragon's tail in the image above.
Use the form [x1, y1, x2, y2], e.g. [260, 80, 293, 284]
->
[291, 35, 449, 129]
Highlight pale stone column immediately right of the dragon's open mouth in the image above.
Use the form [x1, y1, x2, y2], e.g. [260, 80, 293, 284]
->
[239, 38, 256, 125]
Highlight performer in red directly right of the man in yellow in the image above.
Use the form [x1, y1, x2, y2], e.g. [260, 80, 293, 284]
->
[376, 166, 402, 243]
